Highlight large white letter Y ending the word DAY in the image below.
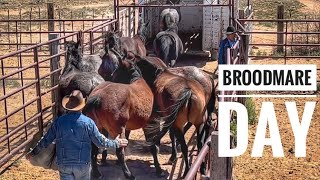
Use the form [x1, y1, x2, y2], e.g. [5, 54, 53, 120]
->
[286, 102, 316, 157]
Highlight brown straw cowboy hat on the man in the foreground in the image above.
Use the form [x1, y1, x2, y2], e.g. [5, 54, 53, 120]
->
[62, 90, 86, 111]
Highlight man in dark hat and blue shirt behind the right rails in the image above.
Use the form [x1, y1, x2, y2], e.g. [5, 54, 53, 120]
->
[218, 26, 237, 64]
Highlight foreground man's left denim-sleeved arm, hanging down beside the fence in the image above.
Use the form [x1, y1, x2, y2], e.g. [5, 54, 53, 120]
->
[31, 119, 58, 155]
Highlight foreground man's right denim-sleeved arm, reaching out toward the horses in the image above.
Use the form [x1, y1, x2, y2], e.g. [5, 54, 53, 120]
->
[89, 120, 120, 148]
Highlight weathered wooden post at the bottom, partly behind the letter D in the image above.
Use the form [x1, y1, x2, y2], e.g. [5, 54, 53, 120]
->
[210, 131, 233, 180]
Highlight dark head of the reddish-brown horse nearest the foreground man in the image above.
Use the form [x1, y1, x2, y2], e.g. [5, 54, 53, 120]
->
[112, 59, 142, 84]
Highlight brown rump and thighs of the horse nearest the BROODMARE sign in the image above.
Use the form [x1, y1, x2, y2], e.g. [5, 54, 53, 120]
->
[155, 71, 207, 130]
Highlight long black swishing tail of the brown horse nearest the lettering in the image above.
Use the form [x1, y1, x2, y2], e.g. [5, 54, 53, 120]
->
[145, 88, 192, 145]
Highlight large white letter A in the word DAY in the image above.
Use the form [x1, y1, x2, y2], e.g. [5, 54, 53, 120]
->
[251, 102, 284, 157]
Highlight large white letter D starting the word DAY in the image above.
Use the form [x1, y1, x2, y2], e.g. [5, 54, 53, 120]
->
[218, 102, 248, 157]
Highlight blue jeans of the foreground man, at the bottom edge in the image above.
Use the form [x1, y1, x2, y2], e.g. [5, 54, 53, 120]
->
[59, 164, 91, 180]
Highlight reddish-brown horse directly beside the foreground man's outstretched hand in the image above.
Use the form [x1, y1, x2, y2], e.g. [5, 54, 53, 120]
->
[84, 60, 154, 179]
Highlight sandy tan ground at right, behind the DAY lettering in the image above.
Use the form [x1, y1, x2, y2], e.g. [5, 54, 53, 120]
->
[234, 0, 320, 179]
